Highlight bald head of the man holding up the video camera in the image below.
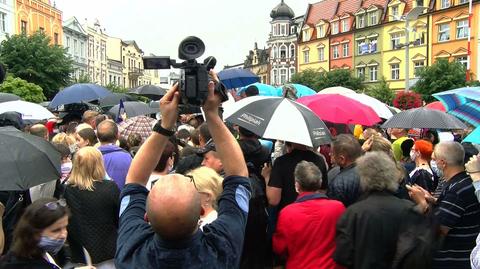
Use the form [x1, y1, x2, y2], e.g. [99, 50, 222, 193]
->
[147, 174, 201, 240]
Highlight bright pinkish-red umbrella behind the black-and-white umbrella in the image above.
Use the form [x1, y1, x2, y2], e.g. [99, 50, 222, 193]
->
[297, 94, 381, 126]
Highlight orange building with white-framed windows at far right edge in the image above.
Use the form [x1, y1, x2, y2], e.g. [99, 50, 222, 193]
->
[429, 0, 480, 80]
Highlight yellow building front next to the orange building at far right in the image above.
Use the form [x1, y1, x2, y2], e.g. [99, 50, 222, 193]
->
[382, 0, 429, 90]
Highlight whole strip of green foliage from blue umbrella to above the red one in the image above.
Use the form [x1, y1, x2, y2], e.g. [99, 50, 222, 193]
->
[291, 69, 365, 92]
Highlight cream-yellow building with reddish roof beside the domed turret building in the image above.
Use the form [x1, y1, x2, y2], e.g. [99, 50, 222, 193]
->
[297, 0, 338, 72]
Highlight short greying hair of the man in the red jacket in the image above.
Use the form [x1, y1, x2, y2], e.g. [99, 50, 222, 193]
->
[294, 161, 323, 191]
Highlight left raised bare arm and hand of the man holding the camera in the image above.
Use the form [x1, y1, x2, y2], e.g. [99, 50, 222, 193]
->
[126, 84, 180, 186]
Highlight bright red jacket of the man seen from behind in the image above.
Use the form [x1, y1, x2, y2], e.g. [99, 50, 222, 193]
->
[273, 192, 345, 269]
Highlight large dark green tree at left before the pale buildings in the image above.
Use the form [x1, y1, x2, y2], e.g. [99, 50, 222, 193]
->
[0, 32, 73, 99]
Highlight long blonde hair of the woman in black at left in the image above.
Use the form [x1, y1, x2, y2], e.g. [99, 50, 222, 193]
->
[68, 147, 106, 191]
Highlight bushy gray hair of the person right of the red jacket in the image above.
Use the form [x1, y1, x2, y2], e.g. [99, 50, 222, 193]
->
[357, 151, 401, 192]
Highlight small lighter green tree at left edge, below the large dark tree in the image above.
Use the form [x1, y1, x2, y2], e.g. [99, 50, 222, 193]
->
[0, 75, 45, 103]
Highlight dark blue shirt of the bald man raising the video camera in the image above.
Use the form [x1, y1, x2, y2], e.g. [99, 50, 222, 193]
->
[115, 176, 250, 269]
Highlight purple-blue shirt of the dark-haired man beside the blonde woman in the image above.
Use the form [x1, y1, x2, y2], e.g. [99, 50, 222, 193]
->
[98, 145, 132, 190]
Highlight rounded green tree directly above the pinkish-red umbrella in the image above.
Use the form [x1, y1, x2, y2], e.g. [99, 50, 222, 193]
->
[315, 69, 365, 92]
